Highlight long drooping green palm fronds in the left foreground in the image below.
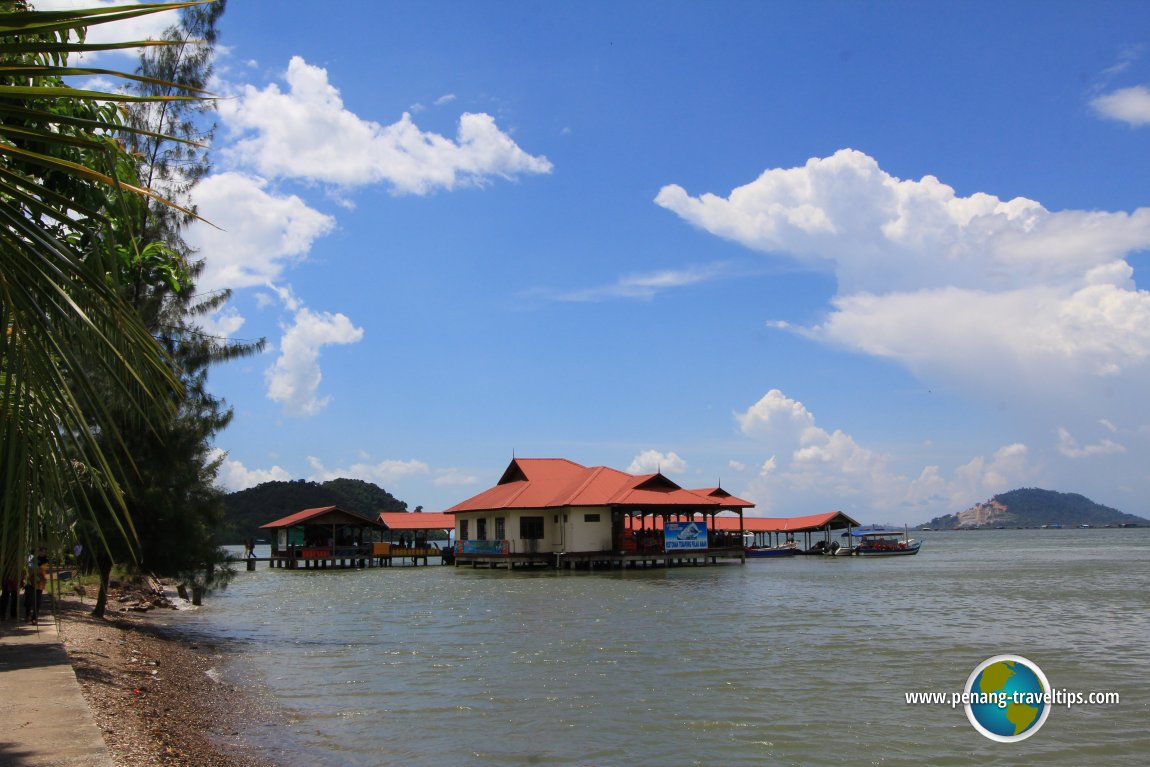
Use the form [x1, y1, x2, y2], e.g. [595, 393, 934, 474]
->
[0, 0, 207, 588]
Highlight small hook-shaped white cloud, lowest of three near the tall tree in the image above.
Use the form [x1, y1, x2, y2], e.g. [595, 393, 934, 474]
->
[266, 307, 363, 415]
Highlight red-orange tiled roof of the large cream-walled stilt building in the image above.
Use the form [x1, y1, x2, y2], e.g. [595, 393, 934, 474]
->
[446, 458, 754, 514]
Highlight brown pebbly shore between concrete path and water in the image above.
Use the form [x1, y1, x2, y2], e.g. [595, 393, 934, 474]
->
[59, 598, 284, 767]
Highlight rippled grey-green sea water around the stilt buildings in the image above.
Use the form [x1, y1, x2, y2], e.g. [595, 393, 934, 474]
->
[168, 528, 1150, 767]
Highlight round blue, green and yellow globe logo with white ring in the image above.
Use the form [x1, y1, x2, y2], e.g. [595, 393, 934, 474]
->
[964, 655, 1051, 743]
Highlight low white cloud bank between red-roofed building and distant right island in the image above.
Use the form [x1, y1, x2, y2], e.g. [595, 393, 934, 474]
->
[734, 389, 1034, 522]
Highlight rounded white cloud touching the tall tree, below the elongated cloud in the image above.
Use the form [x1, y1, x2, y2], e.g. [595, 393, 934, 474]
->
[187, 171, 336, 290]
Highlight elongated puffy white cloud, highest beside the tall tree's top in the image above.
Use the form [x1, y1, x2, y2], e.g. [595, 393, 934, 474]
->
[220, 56, 552, 194]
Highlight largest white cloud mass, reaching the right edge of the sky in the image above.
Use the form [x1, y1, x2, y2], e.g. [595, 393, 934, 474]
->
[656, 149, 1150, 420]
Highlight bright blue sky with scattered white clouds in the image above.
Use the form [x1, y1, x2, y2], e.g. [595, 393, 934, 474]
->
[49, 0, 1150, 524]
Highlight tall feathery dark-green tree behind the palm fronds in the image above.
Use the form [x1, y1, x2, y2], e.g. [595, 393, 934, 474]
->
[83, 1, 262, 611]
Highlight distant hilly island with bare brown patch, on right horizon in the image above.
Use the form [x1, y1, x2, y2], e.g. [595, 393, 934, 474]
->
[919, 488, 1150, 530]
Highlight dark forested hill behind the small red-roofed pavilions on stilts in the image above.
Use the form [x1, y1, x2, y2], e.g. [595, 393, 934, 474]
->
[216, 478, 407, 544]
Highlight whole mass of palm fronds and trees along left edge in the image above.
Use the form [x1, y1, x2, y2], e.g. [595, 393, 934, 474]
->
[0, 0, 244, 614]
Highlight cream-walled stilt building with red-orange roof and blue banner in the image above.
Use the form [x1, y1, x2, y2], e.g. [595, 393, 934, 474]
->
[446, 458, 753, 569]
